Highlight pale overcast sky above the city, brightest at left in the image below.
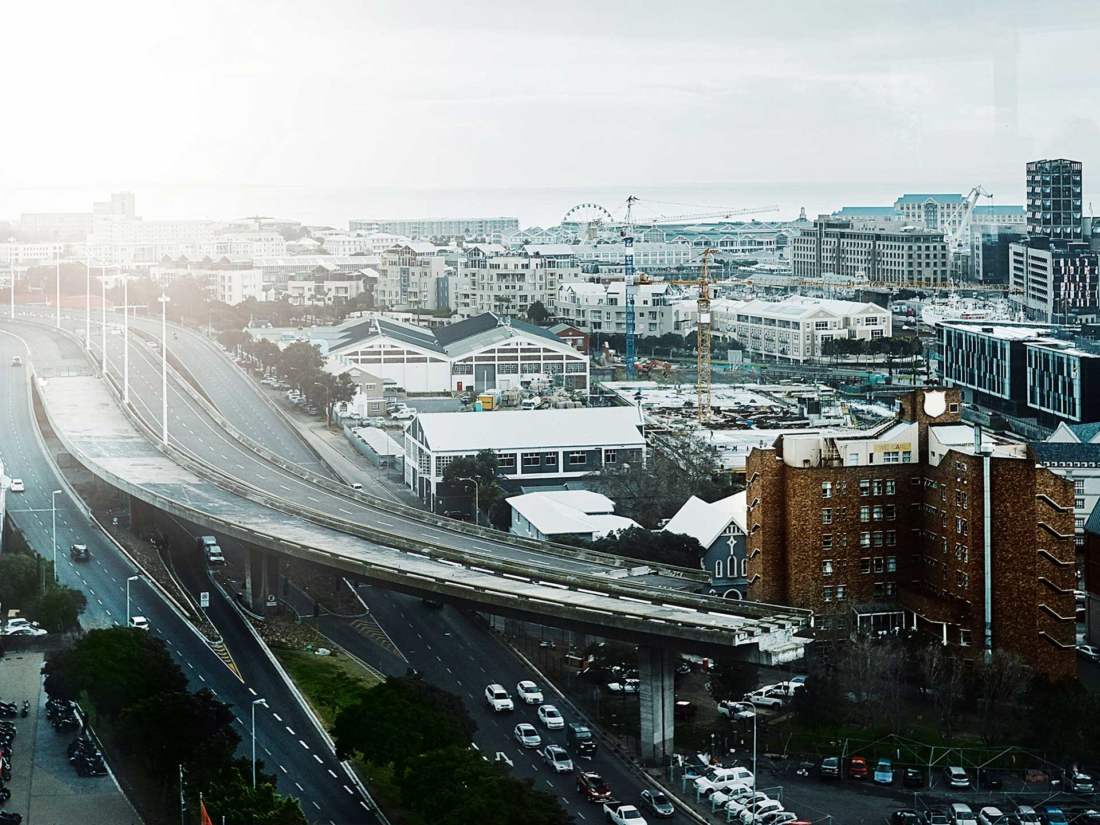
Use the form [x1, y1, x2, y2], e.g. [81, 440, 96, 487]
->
[0, 0, 1100, 217]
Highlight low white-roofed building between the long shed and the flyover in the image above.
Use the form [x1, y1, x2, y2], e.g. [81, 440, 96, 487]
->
[507, 490, 639, 541]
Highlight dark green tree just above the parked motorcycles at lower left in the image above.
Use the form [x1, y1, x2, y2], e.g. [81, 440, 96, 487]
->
[45, 627, 187, 717]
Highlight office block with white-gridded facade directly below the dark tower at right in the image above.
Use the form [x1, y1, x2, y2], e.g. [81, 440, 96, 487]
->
[1009, 238, 1100, 323]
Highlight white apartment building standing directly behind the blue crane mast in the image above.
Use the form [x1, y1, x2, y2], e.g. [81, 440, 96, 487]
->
[554, 281, 699, 338]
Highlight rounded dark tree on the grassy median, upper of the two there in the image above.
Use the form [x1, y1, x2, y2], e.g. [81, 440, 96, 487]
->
[332, 678, 476, 776]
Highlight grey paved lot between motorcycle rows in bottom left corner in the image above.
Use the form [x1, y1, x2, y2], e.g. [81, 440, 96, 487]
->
[0, 651, 141, 825]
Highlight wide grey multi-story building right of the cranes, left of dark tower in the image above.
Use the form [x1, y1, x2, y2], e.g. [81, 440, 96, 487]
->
[791, 215, 948, 286]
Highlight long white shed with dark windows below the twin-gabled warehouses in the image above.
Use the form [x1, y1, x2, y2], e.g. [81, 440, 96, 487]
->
[405, 407, 646, 507]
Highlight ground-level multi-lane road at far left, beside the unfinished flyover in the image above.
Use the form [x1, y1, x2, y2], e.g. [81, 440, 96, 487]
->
[0, 328, 373, 823]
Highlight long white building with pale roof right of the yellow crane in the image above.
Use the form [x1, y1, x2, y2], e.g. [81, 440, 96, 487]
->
[711, 295, 893, 362]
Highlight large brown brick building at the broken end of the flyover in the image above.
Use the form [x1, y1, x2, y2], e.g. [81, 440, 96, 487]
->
[746, 389, 1076, 677]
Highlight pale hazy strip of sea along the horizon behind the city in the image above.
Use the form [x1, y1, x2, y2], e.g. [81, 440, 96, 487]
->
[0, 180, 1023, 229]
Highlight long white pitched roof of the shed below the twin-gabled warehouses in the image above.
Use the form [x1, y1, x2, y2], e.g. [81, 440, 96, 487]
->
[416, 407, 646, 452]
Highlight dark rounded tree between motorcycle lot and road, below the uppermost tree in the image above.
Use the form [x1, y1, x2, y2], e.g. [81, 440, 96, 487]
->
[118, 690, 241, 785]
